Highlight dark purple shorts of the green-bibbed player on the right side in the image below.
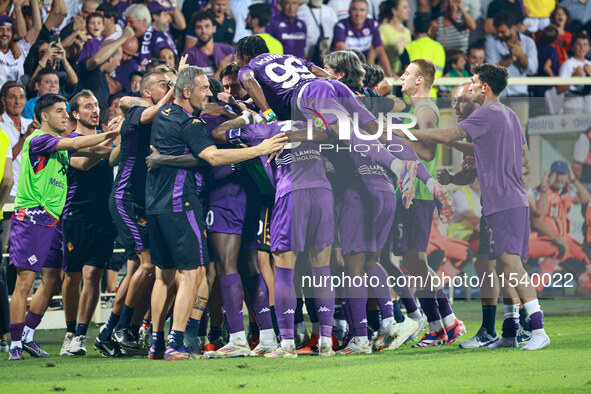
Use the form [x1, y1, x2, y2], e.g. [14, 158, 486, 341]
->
[392, 198, 435, 256]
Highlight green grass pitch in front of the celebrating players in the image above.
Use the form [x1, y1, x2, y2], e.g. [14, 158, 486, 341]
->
[0, 299, 591, 393]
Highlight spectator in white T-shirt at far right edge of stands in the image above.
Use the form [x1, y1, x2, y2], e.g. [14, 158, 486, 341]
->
[556, 33, 591, 114]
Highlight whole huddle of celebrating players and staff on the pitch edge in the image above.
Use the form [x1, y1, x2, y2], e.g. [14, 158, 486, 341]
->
[9, 32, 550, 360]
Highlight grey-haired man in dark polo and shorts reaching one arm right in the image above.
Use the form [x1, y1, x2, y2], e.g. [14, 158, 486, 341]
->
[146, 66, 287, 360]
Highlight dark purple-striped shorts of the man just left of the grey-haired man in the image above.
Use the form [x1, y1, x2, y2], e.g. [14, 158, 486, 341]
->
[109, 198, 150, 260]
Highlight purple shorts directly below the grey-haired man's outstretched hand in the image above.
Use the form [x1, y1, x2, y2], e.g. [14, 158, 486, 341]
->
[271, 188, 334, 252]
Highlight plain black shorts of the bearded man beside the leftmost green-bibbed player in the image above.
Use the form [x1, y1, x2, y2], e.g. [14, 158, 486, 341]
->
[62, 219, 116, 272]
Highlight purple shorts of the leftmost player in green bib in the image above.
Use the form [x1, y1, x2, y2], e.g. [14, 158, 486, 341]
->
[10, 216, 64, 272]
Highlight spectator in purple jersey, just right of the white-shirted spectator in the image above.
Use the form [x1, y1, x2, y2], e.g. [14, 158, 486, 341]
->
[333, 0, 394, 77]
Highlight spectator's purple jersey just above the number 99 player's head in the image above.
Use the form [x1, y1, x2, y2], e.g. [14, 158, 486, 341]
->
[265, 13, 307, 58]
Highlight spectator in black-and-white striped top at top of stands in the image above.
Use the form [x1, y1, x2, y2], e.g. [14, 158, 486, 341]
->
[431, 0, 476, 53]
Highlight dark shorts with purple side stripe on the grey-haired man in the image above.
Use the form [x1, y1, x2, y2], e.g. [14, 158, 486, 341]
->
[148, 209, 209, 269]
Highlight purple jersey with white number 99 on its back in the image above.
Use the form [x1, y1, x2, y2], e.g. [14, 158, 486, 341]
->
[238, 53, 316, 120]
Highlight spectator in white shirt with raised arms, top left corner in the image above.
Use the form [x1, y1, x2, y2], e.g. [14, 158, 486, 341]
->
[0, 0, 42, 85]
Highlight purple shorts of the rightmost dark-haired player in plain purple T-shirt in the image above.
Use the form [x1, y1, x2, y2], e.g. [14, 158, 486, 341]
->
[486, 207, 530, 260]
